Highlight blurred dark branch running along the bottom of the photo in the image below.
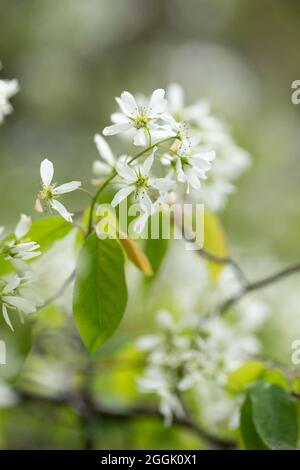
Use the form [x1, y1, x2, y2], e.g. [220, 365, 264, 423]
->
[18, 390, 236, 449]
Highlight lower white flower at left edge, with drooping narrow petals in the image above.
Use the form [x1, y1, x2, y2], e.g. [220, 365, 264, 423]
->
[0, 275, 40, 330]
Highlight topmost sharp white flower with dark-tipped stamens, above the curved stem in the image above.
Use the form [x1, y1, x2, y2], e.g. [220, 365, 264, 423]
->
[103, 88, 173, 145]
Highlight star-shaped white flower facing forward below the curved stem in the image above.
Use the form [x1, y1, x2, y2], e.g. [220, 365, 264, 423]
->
[111, 149, 174, 214]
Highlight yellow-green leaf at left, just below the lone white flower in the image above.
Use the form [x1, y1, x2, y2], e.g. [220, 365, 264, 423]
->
[27, 216, 73, 253]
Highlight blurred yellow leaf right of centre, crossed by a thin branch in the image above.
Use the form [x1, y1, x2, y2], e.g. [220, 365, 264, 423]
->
[204, 210, 228, 280]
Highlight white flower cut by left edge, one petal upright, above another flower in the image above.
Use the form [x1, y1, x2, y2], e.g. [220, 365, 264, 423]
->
[0, 214, 41, 261]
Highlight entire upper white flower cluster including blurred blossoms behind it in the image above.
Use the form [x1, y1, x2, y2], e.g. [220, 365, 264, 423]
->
[94, 84, 249, 231]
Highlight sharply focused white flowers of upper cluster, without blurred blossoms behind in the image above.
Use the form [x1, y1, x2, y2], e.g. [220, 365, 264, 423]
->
[94, 89, 215, 231]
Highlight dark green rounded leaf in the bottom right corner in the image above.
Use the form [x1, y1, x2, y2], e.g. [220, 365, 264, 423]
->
[243, 382, 298, 450]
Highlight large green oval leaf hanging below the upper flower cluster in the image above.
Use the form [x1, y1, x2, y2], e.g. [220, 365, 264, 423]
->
[73, 234, 127, 352]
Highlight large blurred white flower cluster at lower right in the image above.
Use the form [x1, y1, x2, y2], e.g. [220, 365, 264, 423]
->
[137, 265, 267, 429]
